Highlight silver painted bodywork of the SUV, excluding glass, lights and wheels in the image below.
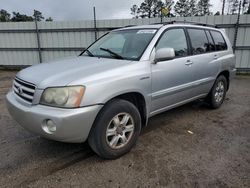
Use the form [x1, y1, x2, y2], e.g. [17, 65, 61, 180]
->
[7, 24, 236, 142]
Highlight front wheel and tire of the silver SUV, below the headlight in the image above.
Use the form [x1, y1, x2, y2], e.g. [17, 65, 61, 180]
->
[88, 99, 141, 159]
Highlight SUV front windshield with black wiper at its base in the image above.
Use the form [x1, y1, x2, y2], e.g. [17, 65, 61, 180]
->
[83, 29, 156, 60]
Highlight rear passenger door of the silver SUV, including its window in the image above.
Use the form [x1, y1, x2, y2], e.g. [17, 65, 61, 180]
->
[187, 28, 219, 96]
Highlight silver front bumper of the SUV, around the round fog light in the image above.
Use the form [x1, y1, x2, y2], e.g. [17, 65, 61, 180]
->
[6, 91, 102, 143]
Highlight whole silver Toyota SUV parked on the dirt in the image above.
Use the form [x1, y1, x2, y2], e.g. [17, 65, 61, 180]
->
[7, 22, 236, 159]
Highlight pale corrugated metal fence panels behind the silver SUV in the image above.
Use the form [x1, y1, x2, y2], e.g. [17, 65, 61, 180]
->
[0, 15, 250, 70]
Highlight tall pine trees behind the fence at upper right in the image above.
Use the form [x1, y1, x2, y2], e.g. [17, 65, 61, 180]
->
[130, 0, 250, 18]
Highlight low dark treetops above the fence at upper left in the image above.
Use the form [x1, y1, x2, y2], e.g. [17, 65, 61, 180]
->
[0, 9, 53, 22]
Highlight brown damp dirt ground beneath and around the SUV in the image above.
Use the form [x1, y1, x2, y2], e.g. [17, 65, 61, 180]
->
[0, 71, 250, 188]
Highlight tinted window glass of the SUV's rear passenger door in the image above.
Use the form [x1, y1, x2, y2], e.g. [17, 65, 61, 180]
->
[188, 29, 210, 54]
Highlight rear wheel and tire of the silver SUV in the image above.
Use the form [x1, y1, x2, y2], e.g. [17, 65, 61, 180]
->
[207, 75, 228, 109]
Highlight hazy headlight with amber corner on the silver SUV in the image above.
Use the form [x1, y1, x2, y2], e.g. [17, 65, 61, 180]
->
[40, 86, 85, 108]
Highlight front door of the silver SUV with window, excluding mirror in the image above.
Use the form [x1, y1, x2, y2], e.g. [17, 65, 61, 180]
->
[151, 28, 195, 114]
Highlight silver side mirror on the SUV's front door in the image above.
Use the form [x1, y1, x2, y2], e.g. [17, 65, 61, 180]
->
[155, 48, 175, 63]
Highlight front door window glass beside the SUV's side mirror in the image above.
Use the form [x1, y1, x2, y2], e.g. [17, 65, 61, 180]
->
[156, 29, 188, 57]
